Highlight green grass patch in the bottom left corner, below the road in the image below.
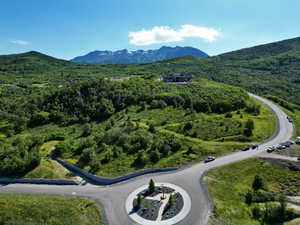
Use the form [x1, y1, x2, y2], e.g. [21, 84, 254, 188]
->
[0, 194, 103, 225]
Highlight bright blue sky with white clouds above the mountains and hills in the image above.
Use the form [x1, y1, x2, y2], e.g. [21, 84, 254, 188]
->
[0, 0, 300, 59]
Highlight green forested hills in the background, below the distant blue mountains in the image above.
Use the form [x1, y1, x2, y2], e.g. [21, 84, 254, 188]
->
[0, 38, 300, 104]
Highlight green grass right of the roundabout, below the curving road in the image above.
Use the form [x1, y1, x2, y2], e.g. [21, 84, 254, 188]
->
[205, 159, 300, 225]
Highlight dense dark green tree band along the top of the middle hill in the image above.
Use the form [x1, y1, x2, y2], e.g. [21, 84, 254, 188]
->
[0, 79, 248, 135]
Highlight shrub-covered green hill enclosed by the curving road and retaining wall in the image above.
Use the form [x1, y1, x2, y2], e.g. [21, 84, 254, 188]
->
[0, 78, 275, 177]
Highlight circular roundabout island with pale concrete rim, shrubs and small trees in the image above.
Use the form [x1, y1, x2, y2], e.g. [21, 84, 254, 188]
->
[125, 181, 191, 225]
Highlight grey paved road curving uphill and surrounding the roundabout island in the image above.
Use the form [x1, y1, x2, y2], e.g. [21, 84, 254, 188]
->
[0, 94, 293, 225]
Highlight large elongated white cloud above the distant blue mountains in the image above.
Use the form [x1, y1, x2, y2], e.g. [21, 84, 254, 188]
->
[129, 24, 221, 46]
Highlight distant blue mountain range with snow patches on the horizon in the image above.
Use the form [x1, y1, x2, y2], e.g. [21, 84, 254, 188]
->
[71, 46, 209, 64]
